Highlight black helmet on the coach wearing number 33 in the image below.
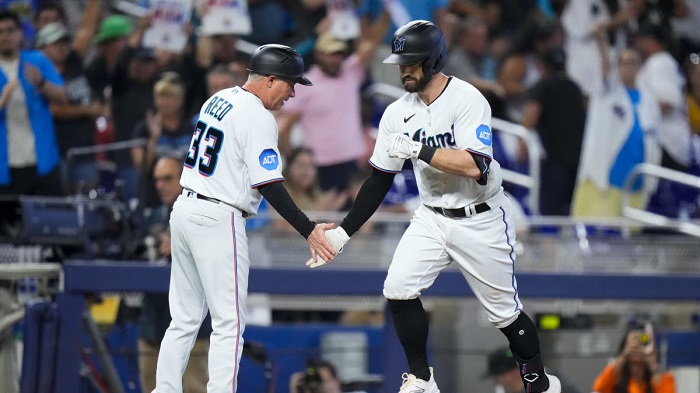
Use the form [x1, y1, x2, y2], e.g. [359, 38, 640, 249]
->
[247, 44, 312, 86]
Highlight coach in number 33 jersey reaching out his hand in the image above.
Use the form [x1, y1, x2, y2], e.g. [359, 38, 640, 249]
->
[154, 45, 335, 393]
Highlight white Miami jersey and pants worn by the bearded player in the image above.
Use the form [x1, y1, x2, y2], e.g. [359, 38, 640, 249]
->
[370, 77, 522, 328]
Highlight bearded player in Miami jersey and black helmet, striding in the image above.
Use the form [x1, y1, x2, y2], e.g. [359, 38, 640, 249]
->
[307, 20, 561, 393]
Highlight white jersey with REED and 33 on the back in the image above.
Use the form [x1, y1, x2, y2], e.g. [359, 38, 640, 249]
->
[180, 86, 283, 215]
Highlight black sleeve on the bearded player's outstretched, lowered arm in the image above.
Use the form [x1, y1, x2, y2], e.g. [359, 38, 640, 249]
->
[340, 169, 396, 236]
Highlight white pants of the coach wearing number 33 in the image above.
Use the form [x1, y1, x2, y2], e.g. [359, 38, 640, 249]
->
[154, 193, 250, 393]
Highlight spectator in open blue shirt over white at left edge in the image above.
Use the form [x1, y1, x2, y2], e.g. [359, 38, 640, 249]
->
[0, 10, 66, 195]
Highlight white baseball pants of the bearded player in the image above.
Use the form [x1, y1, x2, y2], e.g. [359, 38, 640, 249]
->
[384, 193, 522, 328]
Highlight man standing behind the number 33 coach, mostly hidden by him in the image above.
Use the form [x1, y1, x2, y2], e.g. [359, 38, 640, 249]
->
[138, 156, 211, 393]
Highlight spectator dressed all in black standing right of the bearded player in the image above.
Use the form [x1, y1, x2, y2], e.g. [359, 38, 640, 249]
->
[520, 49, 586, 216]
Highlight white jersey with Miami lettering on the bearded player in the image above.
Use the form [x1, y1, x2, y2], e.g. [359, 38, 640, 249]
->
[370, 77, 502, 209]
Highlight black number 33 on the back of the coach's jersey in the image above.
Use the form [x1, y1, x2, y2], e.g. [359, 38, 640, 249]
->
[185, 120, 224, 177]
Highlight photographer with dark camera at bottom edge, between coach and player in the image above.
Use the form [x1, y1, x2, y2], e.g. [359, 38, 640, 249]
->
[289, 360, 364, 393]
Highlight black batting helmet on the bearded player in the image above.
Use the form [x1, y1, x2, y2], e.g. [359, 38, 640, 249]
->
[384, 20, 447, 75]
